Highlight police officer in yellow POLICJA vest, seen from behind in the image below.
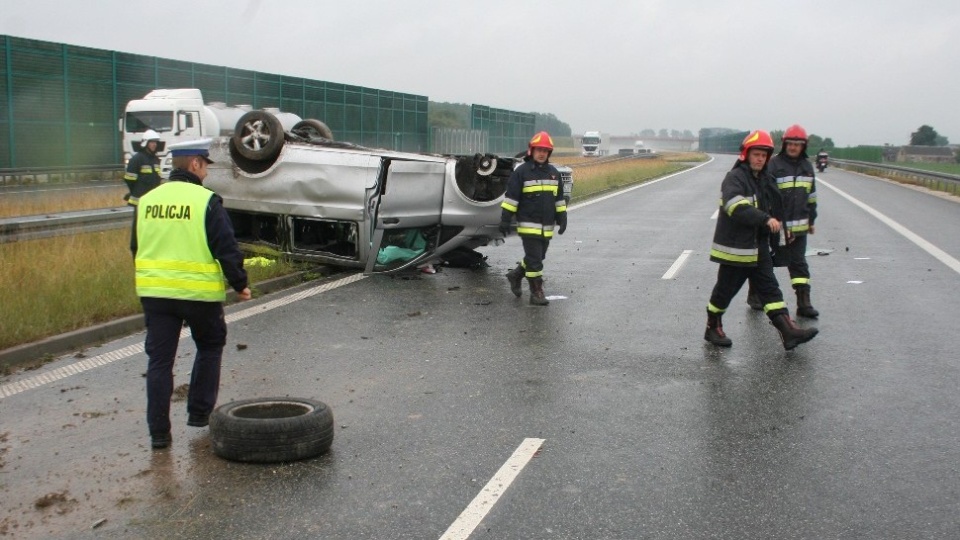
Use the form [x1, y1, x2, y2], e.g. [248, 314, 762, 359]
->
[130, 139, 250, 448]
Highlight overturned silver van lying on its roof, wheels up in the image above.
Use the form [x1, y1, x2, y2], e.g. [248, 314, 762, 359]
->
[204, 111, 573, 274]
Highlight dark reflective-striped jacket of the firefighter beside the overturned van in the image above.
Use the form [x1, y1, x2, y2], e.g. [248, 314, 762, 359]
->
[500, 159, 567, 239]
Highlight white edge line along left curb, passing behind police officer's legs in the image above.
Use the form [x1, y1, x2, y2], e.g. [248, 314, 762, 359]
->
[0, 273, 364, 399]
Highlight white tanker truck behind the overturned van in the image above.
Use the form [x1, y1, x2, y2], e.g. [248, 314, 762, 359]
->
[120, 88, 308, 178]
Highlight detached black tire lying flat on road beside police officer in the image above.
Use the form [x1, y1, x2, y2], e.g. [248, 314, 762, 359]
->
[210, 398, 333, 463]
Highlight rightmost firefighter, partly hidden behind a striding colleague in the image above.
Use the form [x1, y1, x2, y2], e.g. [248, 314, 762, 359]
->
[747, 124, 820, 319]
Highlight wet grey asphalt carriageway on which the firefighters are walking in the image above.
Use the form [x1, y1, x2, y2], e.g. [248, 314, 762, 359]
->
[0, 156, 960, 539]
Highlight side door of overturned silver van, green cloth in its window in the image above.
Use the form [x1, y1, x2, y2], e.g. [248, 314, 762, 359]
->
[365, 158, 446, 274]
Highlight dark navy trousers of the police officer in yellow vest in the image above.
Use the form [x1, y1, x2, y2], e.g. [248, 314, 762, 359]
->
[140, 298, 227, 434]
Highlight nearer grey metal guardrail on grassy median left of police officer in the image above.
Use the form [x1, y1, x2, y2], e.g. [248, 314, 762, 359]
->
[0, 206, 133, 244]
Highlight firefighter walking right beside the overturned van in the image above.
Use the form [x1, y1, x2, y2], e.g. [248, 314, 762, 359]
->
[500, 131, 567, 306]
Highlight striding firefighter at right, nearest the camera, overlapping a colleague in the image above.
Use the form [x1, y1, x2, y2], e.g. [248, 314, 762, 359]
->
[703, 131, 817, 350]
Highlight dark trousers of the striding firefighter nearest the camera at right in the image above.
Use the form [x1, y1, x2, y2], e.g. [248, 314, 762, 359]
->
[707, 242, 788, 320]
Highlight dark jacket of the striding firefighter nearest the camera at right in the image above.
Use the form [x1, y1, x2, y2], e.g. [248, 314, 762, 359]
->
[710, 161, 783, 266]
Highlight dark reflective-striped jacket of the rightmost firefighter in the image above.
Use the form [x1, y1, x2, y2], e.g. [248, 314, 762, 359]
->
[767, 152, 817, 235]
